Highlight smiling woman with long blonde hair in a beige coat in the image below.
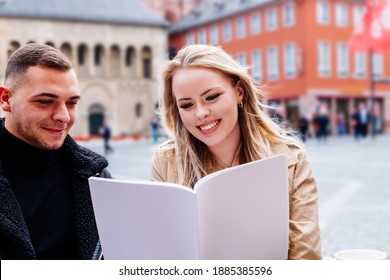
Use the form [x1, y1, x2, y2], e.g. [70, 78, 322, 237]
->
[152, 45, 321, 259]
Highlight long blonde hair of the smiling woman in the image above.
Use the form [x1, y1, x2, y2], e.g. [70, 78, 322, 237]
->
[155, 45, 299, 187]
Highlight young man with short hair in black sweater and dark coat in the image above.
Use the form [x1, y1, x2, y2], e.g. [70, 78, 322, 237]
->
[0, 43, 110, 260]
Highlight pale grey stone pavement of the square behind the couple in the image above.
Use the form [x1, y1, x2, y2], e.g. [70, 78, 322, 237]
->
[80, 135, 390, 257]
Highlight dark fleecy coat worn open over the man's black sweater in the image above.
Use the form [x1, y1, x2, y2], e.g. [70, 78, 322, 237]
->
[0, 119, 111, 260]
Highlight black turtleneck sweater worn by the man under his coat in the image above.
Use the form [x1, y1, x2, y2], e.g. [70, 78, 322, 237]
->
[0, 128, 80, 260]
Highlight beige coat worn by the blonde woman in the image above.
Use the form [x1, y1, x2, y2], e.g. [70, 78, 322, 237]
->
[152, 143, 321, 260]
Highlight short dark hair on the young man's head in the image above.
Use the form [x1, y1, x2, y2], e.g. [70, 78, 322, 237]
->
[4, 43, 72, 86]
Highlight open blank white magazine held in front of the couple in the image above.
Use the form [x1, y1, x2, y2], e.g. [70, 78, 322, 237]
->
[89, 155, 289, 260]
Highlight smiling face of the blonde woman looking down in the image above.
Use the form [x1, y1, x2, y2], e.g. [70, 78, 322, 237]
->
[172, 67, 243, 149]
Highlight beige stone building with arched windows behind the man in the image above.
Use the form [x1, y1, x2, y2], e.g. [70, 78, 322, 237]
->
[0, 0, 168, 137]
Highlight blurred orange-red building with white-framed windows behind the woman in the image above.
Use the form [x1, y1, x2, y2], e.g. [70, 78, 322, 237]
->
[169, 0, 390, 136]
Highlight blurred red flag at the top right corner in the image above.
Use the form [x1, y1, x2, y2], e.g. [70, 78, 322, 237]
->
[349, 0, 390, 52]
